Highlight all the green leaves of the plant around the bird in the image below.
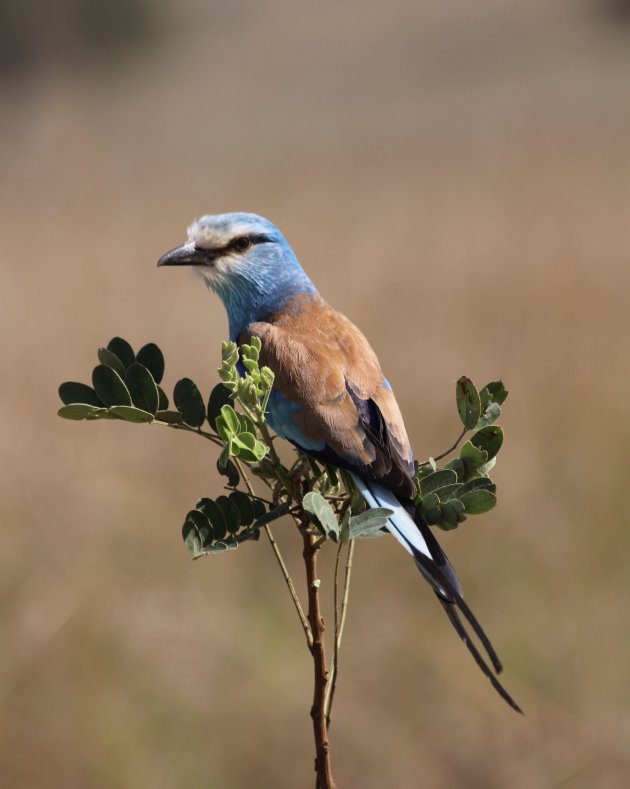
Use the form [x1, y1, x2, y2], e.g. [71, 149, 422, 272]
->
[58, 337, 507, 558]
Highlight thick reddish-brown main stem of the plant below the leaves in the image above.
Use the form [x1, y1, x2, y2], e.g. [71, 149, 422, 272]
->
[301, 522, 336, 789]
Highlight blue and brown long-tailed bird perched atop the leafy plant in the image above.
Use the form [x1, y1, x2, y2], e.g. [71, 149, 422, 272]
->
[157, 212, 522, 713]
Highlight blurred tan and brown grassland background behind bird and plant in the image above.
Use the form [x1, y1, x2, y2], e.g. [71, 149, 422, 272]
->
[0, 0, 630, 789]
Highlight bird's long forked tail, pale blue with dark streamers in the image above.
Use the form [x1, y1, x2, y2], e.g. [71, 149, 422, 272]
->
[352, 474, 522, 714]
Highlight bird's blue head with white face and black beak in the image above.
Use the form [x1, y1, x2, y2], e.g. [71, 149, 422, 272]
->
[158, 213, 317, 340]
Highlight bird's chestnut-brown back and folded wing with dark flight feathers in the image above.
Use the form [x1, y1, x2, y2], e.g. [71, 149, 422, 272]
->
[240, 296, 413, 496]
